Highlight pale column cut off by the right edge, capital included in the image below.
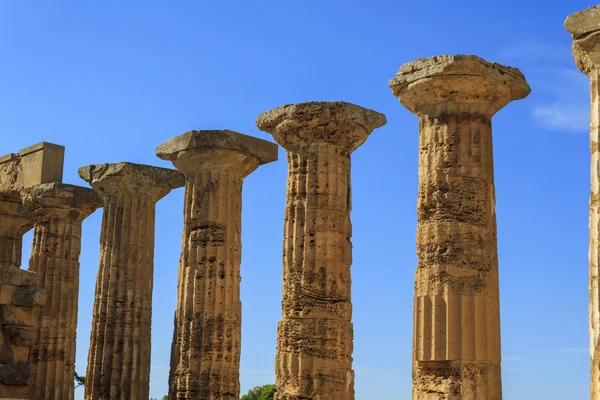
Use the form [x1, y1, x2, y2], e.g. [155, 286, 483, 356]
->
[565, 6, 600, 400]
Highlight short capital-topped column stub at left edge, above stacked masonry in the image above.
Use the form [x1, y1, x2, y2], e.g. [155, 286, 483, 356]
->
[0, 191, 33, 268]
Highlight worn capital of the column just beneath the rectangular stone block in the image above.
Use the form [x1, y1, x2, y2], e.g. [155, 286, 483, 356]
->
[23, 183, 104, 220]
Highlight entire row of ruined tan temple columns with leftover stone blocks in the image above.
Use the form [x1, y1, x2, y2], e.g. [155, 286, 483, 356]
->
[0, 6, 600, 400]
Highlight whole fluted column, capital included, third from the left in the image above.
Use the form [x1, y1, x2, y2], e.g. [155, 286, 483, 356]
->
[79, 163, 184, 400]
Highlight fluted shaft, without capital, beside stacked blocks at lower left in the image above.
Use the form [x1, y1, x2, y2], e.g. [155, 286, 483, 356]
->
[29, 210, 82, 399]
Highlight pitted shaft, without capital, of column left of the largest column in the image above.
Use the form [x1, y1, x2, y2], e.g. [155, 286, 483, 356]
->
[276, 143, 354, 400]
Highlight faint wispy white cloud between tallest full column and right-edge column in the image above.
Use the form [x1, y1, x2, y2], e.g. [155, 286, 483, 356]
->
[532, 102, 589, 132]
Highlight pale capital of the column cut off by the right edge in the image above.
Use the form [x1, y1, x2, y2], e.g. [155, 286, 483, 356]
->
[565, 6, 600, 76]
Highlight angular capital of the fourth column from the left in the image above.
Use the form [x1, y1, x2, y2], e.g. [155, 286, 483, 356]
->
[156, 130, 277, 176]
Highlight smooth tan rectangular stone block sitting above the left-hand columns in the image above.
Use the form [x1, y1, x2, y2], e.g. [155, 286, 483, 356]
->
[19, 142, 65, 188]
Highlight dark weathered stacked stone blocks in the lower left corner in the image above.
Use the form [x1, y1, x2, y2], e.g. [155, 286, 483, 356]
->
[0, 263, 47, 399]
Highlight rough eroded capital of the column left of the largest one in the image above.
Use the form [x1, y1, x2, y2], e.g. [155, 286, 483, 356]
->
[256, 101, 387, 154]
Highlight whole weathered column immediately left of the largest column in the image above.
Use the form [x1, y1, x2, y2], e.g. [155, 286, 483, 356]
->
[257, 102, 386, 400]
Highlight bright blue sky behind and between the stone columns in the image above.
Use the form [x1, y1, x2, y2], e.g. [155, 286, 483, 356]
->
[0, 0, 595, 400]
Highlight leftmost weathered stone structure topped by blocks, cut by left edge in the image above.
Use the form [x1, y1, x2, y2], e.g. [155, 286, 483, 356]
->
[0, 142, 64, 398]
